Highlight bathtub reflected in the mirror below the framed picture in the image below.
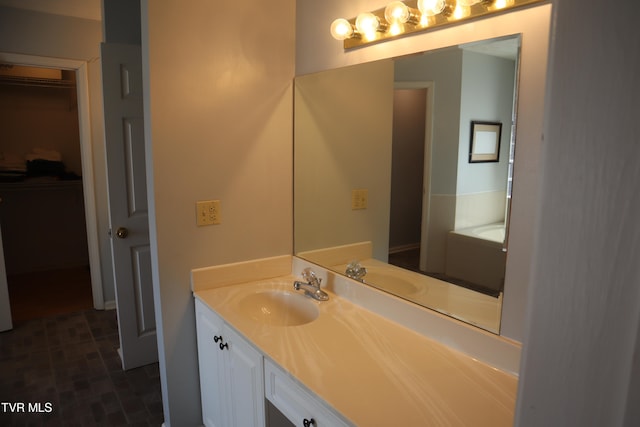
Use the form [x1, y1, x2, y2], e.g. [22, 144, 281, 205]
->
[445, 223, 507, 291]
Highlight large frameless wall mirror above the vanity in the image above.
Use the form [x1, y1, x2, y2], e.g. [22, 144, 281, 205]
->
[294, 35, 520, 333]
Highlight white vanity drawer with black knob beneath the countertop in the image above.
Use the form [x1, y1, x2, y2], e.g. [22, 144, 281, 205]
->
[264, 359, 350, 427]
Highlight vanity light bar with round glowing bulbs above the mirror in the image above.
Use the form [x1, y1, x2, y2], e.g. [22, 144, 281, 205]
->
[331, 0, 545, 49]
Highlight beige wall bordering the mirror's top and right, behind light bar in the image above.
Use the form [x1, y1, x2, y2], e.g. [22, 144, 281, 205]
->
[296, 0, 551, 341]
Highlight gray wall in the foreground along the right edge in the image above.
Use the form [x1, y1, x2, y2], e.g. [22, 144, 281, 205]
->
[516, 0, 640, 426]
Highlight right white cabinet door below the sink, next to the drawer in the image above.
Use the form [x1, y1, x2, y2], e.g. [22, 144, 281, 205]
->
[223, 325, 265, 427]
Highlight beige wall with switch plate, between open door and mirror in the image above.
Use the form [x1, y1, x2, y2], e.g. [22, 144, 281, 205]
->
[142, 0, 295, 426]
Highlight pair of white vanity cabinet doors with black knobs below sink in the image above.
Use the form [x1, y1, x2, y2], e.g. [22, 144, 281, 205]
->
[195, 299, 265, 427]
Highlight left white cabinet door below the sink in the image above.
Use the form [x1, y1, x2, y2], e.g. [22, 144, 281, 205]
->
[196, 299, 230, 427]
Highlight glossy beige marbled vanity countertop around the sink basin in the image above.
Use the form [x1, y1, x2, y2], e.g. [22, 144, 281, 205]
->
[194, 276, 517, 427]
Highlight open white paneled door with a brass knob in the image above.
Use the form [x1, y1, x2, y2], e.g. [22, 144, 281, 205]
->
[101, 43, 158, 369]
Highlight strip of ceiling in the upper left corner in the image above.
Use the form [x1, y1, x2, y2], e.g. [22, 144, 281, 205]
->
[0, 0, 102, 21]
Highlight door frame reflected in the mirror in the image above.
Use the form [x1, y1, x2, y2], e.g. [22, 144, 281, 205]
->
[393, 81, 435, 271]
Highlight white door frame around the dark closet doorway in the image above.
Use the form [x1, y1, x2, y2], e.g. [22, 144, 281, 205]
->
[0, 52, 105, 310]
